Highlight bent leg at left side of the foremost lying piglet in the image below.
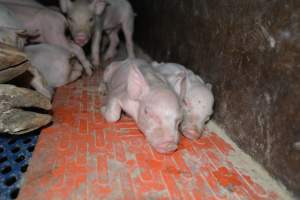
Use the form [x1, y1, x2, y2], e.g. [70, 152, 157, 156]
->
[101, 98, 122, 123]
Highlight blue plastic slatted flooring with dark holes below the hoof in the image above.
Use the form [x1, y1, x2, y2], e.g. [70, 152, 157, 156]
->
[0, 131, 40, 200]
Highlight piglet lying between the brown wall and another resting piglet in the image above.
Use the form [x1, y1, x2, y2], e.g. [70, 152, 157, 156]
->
[152, 62, 214, 139]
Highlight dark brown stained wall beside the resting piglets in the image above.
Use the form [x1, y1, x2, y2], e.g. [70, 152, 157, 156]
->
[131, 0, 300, 193]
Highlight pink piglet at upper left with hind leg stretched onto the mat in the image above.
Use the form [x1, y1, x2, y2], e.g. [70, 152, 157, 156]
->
[1, 0, 92, 75]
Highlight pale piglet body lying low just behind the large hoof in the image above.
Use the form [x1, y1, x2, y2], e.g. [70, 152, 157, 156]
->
[24, 44, 82, 88]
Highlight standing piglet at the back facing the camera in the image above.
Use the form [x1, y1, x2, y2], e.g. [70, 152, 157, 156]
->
[60, 0, 135, 66]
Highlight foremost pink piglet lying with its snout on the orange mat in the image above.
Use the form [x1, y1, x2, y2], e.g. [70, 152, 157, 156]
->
[101, 59, 182, 153]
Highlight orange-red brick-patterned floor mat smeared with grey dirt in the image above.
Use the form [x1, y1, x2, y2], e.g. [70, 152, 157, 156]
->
[19, 71, 288, 200]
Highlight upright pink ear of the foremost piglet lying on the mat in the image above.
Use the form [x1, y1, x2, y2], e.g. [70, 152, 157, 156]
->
[127, 64, 149, 100]
